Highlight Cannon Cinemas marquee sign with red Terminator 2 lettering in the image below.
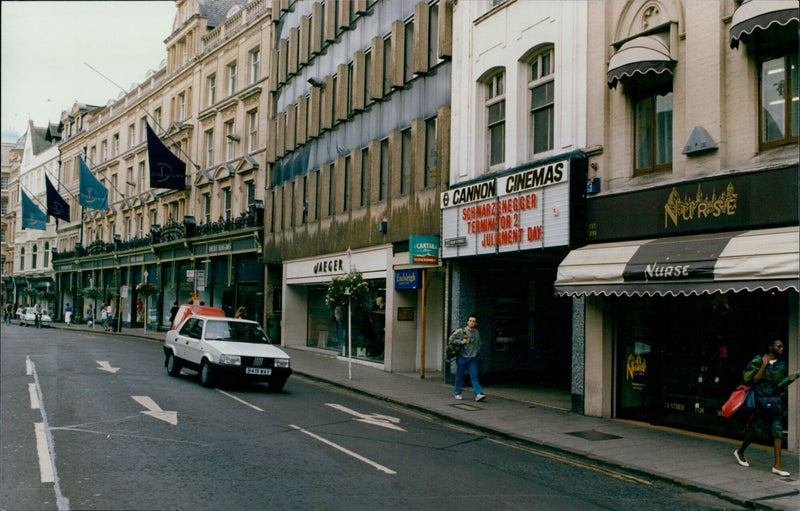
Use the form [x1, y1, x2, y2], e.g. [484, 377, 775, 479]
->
[440, 159, 570, 258]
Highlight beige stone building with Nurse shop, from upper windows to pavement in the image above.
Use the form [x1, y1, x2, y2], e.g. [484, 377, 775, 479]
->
[555, 0, 800, 452]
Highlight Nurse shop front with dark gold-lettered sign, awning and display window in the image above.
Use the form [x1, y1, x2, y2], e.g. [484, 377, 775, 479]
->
[556, 167, 800, 449]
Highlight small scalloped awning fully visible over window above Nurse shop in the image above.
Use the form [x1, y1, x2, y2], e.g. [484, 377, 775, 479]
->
[606, 32, 675, 88]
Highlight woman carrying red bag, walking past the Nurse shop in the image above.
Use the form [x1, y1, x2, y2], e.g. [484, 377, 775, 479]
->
[733, 339, 797, 477]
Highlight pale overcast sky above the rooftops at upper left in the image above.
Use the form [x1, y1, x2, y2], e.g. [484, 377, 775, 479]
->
[0, 0, 176, 142]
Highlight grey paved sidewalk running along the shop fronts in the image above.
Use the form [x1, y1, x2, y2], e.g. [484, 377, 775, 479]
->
[59, 323, 800, 510]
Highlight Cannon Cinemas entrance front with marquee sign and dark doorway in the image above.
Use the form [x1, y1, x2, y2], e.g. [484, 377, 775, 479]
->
[440, 153, 587, 390]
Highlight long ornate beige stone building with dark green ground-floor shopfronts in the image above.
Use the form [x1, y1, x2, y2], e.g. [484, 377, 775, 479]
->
[56, 0, 272, 328]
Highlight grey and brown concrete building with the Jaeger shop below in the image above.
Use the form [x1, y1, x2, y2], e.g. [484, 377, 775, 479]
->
[264, 0, 452, 372]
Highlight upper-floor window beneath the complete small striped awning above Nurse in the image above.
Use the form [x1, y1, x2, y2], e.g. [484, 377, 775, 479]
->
[633, 92, 672, 174]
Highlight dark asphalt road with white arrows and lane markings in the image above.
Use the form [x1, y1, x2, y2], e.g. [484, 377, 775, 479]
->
[0, 325, 748, 511]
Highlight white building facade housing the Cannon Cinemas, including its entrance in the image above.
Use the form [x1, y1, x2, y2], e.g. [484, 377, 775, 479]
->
[440, 1, 588, 391]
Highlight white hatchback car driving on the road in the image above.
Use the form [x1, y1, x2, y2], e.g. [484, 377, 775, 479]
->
[164, 314, 292, 392]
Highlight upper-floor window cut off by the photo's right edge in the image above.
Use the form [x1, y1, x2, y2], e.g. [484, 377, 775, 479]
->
[759, 53, 800, 149]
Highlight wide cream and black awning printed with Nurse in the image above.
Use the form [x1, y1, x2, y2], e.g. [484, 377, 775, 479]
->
[555, 226, 800, 296]
